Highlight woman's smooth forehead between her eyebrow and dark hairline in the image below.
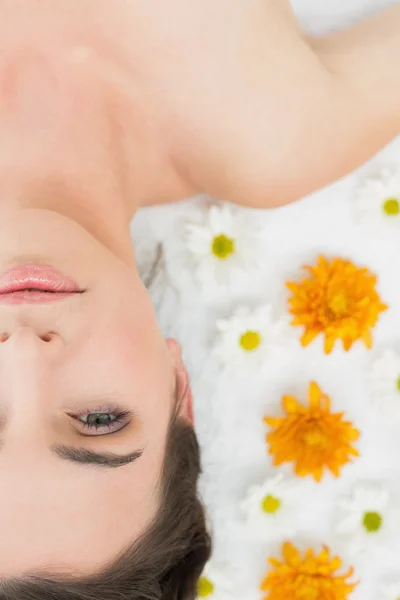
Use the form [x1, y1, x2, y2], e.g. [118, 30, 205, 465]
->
[0, 455, 159, 577]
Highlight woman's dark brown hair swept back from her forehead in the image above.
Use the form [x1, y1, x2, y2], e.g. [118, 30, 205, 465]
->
[0, 418, 211, 600]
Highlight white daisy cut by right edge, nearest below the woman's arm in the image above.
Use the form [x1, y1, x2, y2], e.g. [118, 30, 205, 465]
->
[354, 168, 400, 228]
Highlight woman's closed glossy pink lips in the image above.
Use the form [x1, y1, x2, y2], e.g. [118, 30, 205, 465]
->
[0, 265, 82, 304]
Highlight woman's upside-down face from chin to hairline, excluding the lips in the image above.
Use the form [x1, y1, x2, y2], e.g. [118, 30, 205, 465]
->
[0, 210, 182, 577]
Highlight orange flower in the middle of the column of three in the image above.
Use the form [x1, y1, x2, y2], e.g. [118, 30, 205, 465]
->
[264, 382, 360, 481]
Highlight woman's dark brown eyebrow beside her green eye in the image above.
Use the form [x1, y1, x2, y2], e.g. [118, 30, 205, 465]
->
[52, 446, 143, 469]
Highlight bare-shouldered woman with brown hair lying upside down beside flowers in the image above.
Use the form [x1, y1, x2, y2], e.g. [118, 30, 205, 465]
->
[0, 0, 400, 600]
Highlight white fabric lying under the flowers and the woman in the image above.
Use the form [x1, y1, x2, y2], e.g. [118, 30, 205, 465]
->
[132, 0, 400, 600]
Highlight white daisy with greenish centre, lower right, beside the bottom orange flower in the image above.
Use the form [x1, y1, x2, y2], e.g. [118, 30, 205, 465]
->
[337, 484, 400, 553]
